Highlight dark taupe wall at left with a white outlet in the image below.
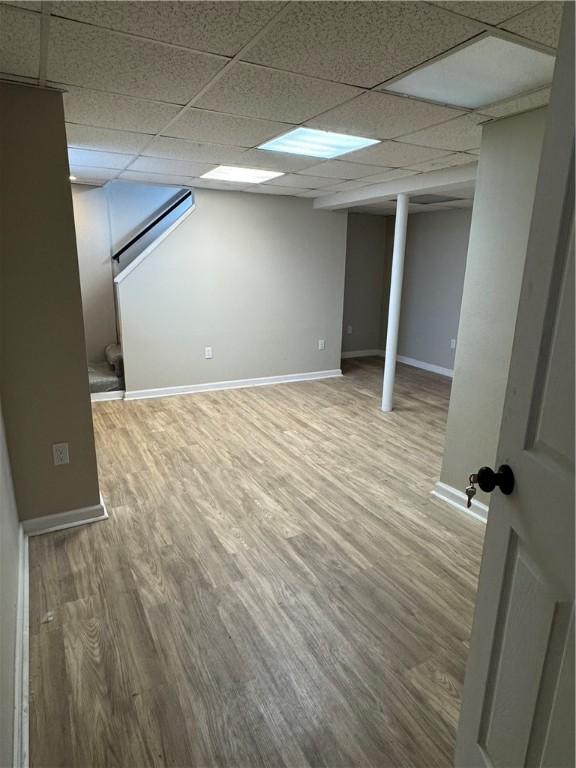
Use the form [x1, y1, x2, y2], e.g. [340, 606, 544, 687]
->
[0, 84, 99, 519]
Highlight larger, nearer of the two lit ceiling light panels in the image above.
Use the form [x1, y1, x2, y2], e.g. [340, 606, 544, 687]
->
[258, 128, 380, 159]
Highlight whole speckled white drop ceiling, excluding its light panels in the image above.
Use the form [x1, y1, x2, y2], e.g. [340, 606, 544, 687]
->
[0, 0, 561, 207]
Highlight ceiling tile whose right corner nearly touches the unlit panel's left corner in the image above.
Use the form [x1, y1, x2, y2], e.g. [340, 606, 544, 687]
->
[196, 64, 360, 123]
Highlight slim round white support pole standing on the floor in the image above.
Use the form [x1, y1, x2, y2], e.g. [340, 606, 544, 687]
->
[382, 194, 409, 411]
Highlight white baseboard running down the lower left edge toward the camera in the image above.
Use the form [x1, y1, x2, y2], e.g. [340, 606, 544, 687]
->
[13, 524, 30, 768]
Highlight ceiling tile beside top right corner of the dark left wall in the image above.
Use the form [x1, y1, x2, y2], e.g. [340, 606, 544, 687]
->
[64, 88, 182, 133]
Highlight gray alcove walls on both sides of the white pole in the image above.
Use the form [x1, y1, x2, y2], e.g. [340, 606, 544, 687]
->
[342, 209, 471, 369]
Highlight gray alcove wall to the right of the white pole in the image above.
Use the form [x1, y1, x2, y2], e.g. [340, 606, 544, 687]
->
[396, 209, 472, 370]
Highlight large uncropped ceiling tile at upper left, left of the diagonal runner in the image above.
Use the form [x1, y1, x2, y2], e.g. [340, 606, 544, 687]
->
[48, 18, 226, 104]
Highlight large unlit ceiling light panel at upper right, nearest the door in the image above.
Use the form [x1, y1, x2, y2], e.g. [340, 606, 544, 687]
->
[386, 36, 554, 109]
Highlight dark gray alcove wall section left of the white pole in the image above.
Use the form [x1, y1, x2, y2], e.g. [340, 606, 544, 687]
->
[342, 213, 390, 352]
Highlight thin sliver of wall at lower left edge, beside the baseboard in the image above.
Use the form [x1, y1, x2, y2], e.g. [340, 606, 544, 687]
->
[0, 409, 20, 766]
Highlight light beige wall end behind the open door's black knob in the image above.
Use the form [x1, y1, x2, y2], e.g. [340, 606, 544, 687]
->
[440, 109, 546, 503]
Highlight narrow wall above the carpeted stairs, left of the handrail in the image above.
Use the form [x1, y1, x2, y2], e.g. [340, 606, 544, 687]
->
[72, 184, 116, 362]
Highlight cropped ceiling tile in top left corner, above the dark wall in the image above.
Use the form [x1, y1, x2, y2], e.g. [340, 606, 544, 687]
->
[0, 5, 40, 78]
